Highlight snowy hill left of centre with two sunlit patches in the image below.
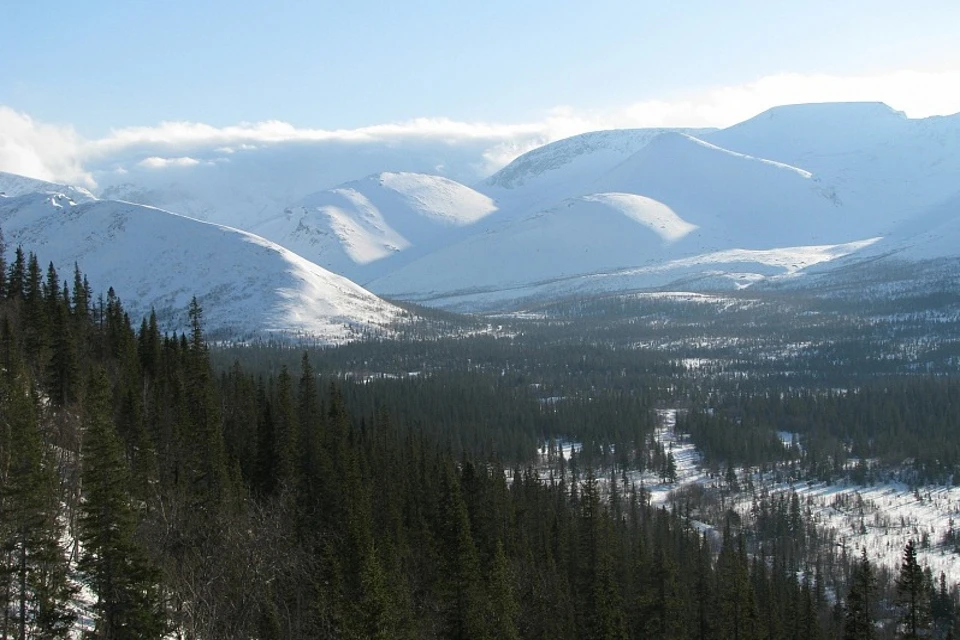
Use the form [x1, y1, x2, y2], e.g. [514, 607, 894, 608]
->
[252, 173, 497, 280]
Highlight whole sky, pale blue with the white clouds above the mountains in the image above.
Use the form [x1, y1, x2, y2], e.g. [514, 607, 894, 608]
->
[0, 0, 960, 185]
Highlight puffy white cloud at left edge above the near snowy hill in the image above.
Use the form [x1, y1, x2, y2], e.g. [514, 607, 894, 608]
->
[0, 105, 94, 187]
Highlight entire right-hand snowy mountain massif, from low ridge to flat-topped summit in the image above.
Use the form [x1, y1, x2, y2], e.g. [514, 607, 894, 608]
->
[369, 103, 960, 309]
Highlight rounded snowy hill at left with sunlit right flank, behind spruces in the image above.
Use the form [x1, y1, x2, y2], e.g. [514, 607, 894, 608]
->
[0, 193, 402, 342]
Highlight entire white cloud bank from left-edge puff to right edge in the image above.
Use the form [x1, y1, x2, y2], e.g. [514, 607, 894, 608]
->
[0, 69, 960, 185]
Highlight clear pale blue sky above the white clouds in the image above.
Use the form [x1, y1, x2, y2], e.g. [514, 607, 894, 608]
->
[0, 0, 960, 138]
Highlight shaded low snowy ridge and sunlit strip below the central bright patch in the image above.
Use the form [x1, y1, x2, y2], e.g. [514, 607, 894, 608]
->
[369, 198, 878, 311]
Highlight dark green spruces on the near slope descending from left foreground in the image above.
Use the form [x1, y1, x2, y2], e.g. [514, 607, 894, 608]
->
[0, 242, 848, 639]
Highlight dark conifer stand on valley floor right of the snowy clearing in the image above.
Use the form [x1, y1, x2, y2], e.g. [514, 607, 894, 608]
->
[678, 377, 960, 483]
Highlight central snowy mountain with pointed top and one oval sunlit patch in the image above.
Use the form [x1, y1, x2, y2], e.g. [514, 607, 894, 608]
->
[369, 132, 864, 309]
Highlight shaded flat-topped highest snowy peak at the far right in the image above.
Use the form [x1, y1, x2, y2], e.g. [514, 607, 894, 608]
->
[704, 103, 960, 233]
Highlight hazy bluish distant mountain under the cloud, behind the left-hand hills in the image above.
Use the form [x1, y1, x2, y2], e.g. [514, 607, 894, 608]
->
[94, 139, 506, 229]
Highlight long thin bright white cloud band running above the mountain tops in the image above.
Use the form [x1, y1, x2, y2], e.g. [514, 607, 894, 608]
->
[77, 69, 960, 166]
